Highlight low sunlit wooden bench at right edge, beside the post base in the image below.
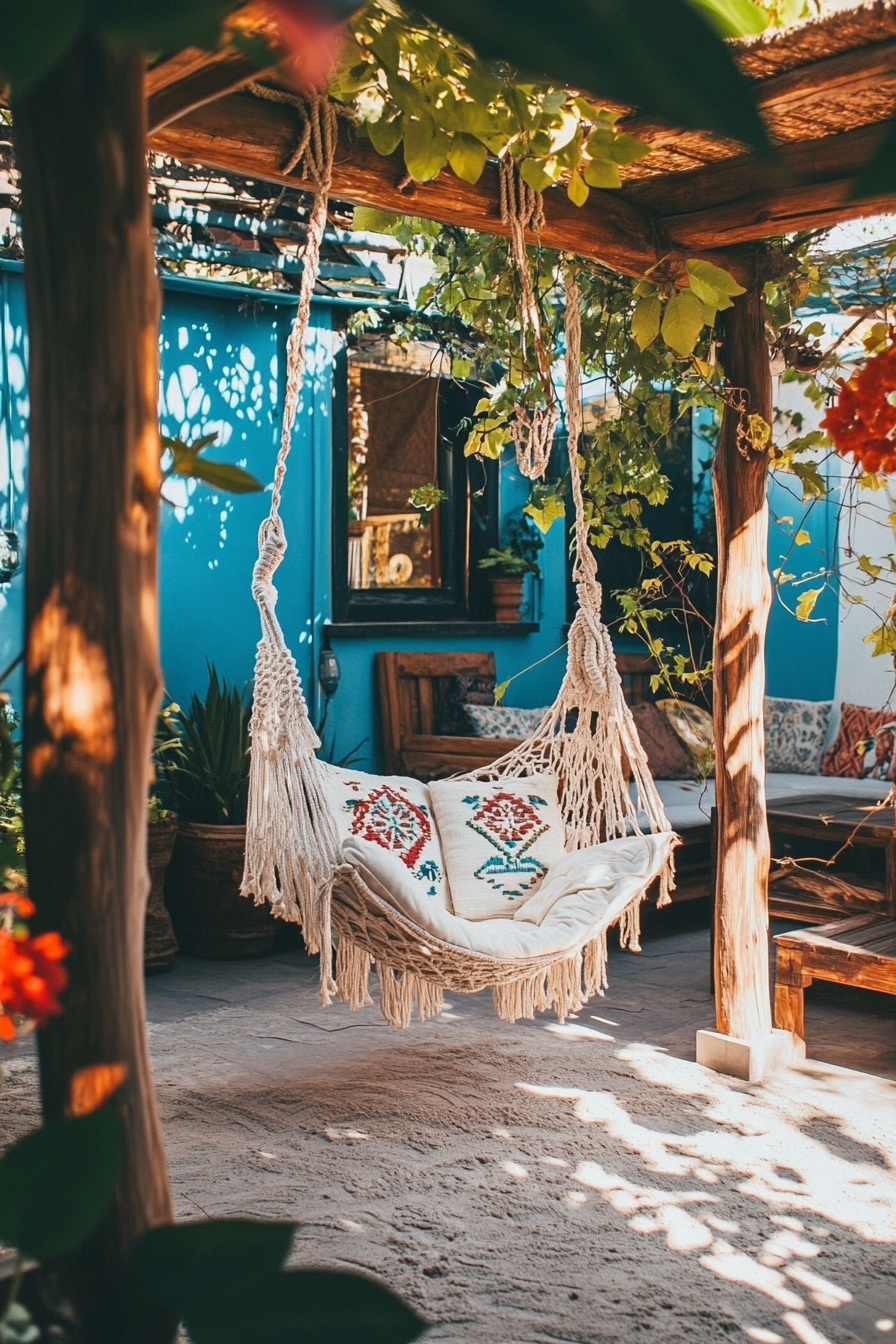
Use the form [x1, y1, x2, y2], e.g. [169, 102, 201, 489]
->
[775, 914, 896, 1040]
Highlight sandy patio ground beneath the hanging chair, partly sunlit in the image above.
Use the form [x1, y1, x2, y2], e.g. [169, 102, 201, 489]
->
[0, 903, 896, 1344]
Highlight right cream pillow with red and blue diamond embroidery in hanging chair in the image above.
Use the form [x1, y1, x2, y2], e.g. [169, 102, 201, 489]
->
[430, 774, 564, 919]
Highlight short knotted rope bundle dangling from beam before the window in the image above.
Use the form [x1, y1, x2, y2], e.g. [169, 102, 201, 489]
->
[498, 155, 560, 480]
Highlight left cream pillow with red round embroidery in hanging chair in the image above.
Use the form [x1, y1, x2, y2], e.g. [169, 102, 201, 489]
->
[326, 766, 450, 910]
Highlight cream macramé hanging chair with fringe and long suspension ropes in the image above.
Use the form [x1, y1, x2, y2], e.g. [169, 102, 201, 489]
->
[242, 97, 677, 1027]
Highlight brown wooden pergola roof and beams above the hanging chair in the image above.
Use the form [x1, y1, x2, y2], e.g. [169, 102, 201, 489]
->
[146, 0, 896, 280]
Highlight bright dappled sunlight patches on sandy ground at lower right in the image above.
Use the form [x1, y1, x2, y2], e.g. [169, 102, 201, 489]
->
[519, 1037, 896, 1344]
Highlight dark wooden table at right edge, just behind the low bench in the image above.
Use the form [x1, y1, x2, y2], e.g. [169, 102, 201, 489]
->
[768, 793, 896, 923]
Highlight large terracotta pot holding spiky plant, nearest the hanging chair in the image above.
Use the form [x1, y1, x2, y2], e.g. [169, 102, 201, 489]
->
[165, 821, 277, 961]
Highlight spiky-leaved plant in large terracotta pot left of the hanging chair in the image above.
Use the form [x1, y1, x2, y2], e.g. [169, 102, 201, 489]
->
[159, 664, 277, 960]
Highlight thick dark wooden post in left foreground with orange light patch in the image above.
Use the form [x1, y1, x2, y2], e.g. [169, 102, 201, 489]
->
[13, 35, 172, 1344]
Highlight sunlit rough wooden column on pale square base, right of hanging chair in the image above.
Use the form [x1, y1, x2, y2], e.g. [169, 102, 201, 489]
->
[697, 286, 789, 1078]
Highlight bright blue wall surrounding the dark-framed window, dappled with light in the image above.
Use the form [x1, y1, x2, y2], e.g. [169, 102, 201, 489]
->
[0, 260, 566, 769]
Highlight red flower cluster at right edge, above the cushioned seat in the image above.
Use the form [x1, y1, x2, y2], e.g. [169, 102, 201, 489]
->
[821, 341, 896, 473]
